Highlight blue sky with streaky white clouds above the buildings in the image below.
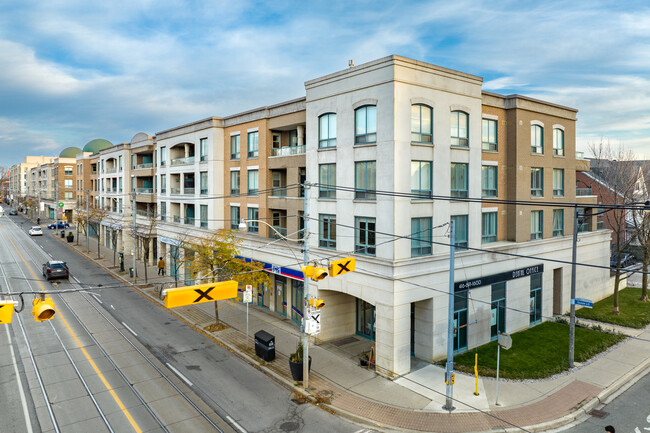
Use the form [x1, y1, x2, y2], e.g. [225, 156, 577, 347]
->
[0, 0, 650, 166]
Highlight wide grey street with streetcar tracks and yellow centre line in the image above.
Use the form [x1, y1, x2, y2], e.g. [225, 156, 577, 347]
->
[0, 211, 380, 433]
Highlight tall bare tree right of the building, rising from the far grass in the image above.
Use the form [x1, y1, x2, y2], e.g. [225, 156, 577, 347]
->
[589, 141, 639, 315]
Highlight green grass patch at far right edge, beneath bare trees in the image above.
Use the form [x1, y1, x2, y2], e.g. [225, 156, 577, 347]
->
[576, 287, 650, 329]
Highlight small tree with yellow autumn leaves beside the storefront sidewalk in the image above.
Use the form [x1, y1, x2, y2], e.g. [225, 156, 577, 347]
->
[185, 230, 270, 326]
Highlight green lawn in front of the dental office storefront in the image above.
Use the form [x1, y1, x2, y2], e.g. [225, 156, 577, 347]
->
[443, 322, 625, 379]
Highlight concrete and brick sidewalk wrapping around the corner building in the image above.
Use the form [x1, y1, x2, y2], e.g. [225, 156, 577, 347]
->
[55, 230, 650, 432]
